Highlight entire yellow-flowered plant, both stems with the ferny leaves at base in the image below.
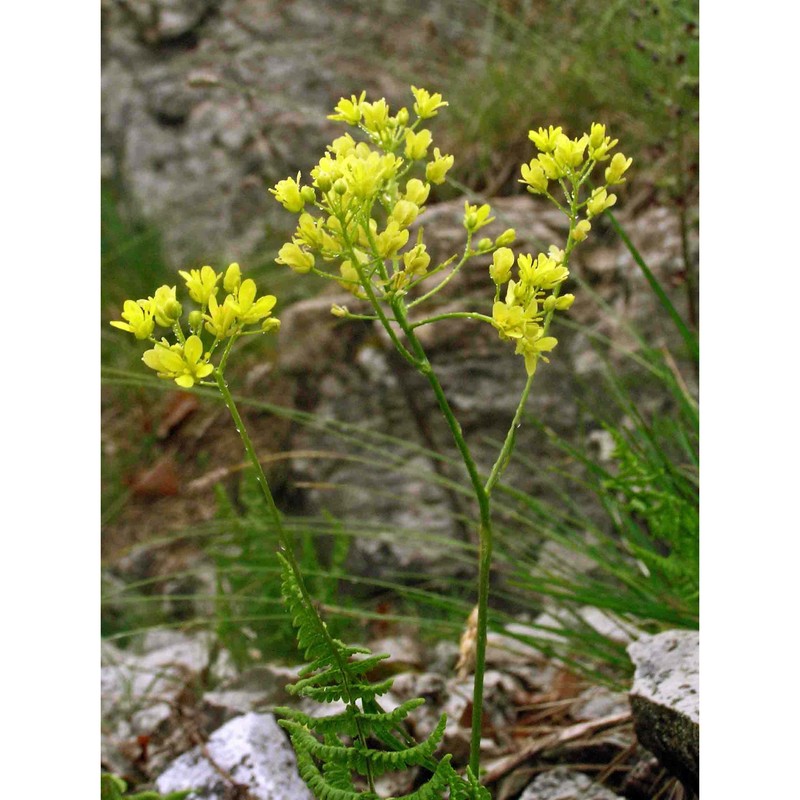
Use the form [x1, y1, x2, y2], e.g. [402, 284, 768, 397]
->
[111, 86, 631, 800]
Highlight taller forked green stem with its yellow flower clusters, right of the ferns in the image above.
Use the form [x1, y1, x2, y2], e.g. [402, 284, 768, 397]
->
[268, 86, 631, 778]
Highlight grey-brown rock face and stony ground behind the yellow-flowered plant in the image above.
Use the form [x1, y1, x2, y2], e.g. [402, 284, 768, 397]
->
[102, 0, 699, 800]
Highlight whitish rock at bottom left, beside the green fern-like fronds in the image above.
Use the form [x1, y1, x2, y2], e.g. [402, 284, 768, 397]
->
[156, 714, 312, 800]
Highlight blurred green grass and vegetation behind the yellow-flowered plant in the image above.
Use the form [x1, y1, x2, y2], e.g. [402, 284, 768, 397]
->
[101, 0, 699, 685]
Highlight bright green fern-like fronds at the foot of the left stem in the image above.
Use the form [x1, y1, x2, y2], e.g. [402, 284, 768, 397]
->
[277, 555, 486, 800]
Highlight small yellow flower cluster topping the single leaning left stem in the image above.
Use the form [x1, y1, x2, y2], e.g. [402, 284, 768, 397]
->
[111, 263, 280, 389]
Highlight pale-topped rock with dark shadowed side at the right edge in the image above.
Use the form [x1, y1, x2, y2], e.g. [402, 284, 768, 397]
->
[628, 631, 700, 792]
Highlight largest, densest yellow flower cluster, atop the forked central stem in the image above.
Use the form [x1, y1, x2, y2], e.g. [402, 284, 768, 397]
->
[270, 87, 454, 297]
